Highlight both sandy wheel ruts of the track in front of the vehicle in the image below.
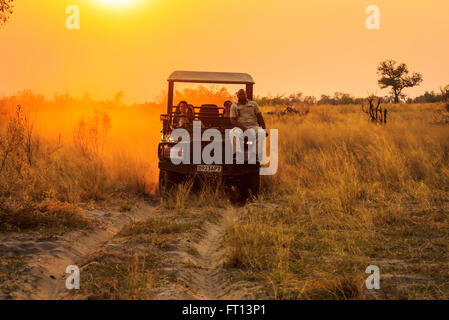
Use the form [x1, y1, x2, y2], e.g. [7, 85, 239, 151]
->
[0, 205, 263, 300]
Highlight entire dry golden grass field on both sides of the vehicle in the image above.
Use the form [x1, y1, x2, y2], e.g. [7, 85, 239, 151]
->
[0, 93, 449, 299]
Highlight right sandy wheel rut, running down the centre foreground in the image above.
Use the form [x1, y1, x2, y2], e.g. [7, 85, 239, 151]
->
[154, 208, 261, 300]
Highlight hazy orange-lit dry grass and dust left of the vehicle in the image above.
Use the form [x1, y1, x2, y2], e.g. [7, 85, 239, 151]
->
[0, 93, 159, 234]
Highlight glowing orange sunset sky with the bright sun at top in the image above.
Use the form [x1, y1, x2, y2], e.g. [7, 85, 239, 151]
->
[0, 0, 449, 102]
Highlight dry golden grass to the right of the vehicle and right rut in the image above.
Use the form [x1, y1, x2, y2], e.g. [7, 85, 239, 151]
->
[225, 104, 449, 299]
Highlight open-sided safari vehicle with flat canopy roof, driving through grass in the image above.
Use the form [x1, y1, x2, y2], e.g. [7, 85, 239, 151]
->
[158, 71, 260, 200]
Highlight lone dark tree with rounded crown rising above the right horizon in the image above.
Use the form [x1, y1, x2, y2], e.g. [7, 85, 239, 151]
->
[377, 60, 423, 103]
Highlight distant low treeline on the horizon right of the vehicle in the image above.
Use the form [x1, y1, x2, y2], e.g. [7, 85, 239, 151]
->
[254, 85, 449, 106]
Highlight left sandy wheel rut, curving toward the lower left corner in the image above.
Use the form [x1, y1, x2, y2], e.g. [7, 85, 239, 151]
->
[0, 205, 153, 300]
